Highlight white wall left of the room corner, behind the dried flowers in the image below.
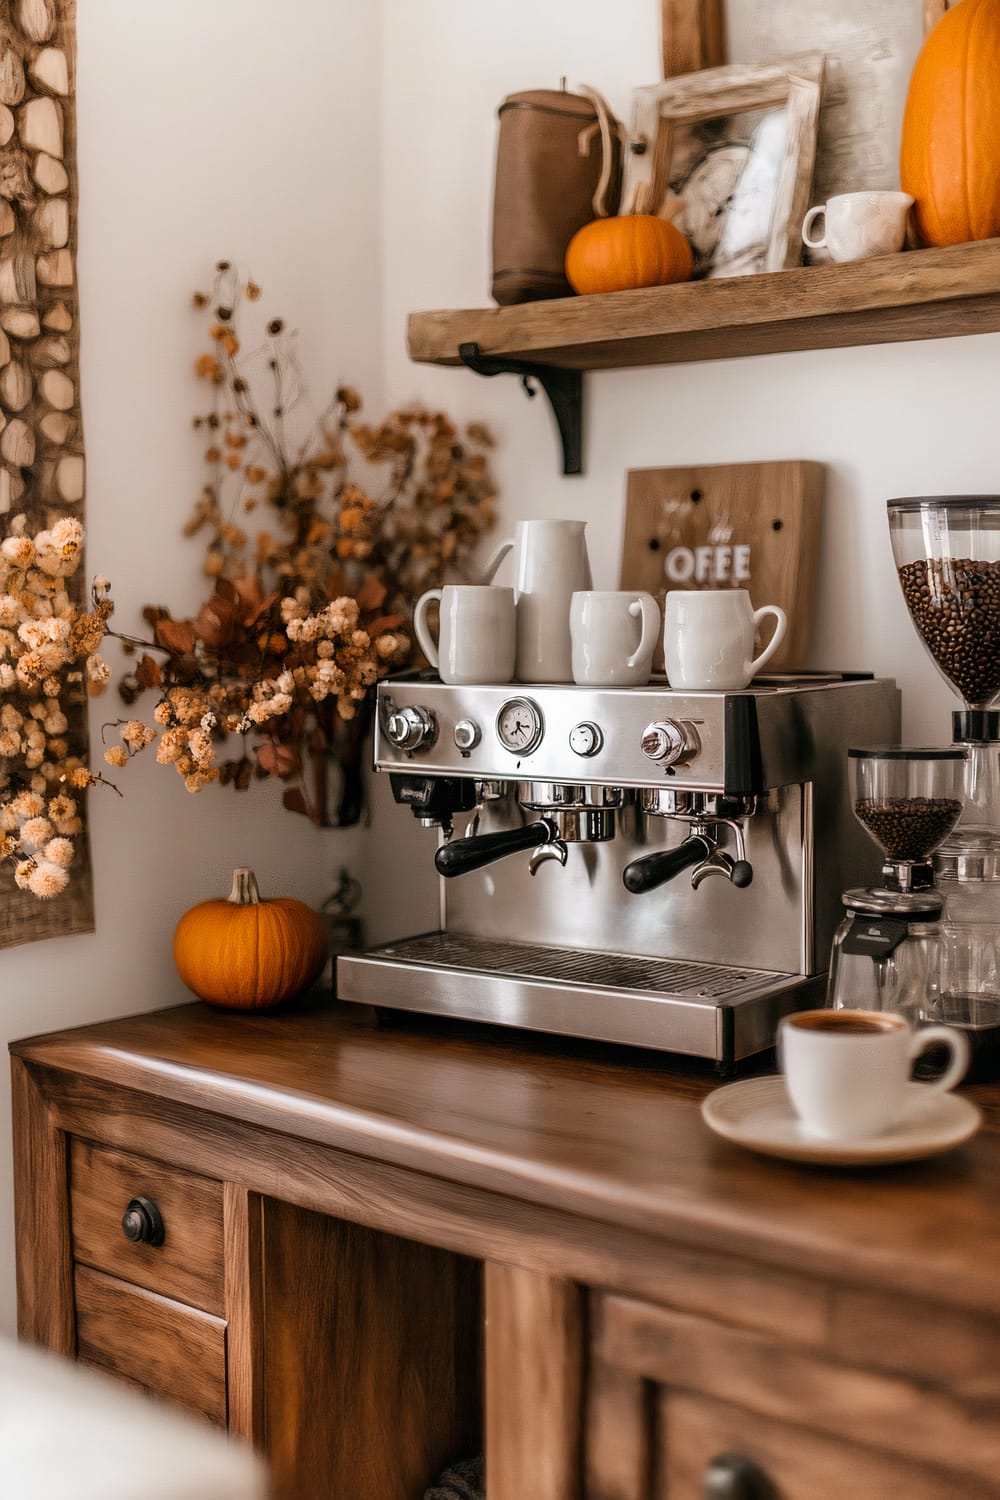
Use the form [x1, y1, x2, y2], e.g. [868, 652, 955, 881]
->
[0, 0, 381, 1328]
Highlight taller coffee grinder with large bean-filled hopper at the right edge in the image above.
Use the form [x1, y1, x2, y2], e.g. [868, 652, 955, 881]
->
[888, 495, 1000, 1077]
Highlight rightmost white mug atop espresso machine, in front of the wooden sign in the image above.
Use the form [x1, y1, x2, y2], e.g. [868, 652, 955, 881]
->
[663, 588, 789, 692]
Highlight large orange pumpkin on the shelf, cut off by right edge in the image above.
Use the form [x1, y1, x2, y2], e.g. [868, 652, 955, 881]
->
[900, 0, 1000, 245]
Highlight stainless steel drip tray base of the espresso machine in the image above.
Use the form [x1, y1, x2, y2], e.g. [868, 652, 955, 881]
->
[337, 932, 826, 1073]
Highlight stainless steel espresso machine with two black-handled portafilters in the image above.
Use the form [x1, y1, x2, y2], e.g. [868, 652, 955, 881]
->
[337, 674, 900, 1071]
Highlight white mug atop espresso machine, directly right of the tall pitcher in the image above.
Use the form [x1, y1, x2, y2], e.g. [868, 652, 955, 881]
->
[570, 590, 660, 687]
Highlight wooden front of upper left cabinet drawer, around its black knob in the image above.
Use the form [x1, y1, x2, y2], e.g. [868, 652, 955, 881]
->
[70, 1140, 223, 1314]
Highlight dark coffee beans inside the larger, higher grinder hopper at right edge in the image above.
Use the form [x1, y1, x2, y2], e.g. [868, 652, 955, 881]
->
[898, 557, 1000, 708]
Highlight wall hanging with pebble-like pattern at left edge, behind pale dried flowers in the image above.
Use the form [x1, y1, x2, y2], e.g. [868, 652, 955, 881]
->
[0, 0, 93, 947]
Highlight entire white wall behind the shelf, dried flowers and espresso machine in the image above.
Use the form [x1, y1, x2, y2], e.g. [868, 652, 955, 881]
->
[7, 0, 1000, 1323]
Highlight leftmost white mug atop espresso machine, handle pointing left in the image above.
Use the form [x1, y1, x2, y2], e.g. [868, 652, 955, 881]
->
[414, 584, 517, 683]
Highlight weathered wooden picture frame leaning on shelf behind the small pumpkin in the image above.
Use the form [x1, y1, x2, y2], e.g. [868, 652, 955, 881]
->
[625, 56, 825, 278]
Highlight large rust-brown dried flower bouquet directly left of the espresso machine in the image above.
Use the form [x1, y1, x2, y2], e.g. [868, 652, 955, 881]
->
[105, 261, 495, 825]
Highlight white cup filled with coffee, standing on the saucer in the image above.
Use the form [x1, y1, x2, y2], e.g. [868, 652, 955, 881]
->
[778, 1011, 969, 1140]
